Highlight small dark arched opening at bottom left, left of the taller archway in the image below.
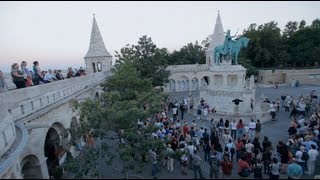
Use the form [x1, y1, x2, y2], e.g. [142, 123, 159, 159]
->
[21, 155, 43, 179]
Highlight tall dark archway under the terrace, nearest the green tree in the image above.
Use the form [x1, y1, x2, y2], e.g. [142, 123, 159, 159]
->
[44, 123, 68, 178]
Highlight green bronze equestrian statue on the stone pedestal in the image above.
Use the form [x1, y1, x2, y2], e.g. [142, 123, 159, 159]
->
[214, 30, 250, 65]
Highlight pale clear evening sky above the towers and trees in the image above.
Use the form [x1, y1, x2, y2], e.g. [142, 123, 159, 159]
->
[0, 1, 320, 72]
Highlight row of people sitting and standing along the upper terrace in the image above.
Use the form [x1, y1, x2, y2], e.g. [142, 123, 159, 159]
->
[0, 61, 86, 92]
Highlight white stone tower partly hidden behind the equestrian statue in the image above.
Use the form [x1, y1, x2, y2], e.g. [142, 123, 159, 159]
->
[206, 11, 225, 65]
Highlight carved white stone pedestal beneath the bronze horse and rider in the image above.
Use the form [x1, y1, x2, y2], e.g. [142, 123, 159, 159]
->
[200, 62, 267, 120]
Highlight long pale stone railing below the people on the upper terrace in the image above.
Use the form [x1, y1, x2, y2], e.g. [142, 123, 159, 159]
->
[0, 72, 110, 122]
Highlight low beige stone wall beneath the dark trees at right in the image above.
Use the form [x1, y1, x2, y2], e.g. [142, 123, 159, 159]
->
[257, 69, 320, 85]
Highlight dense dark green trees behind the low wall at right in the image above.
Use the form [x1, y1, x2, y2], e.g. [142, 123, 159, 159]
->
[240, 19, 320, 68]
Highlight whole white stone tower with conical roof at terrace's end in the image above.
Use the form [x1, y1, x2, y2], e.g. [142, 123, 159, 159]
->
[84, 14, 112, 74]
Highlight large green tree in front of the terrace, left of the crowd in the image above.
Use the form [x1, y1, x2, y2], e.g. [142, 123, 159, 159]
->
[65, 61, 167, 178]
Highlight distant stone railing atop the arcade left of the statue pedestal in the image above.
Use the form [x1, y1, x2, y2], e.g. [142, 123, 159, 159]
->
[167, 64, 210, 72]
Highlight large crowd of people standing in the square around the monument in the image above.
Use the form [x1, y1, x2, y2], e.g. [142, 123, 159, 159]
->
[146, 95, 320, 179]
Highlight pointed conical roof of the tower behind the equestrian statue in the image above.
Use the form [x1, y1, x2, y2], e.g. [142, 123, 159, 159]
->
[207, 11, 225, 52]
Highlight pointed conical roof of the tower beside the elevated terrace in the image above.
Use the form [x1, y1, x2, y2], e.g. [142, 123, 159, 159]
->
[84, 15, 111, 58]
